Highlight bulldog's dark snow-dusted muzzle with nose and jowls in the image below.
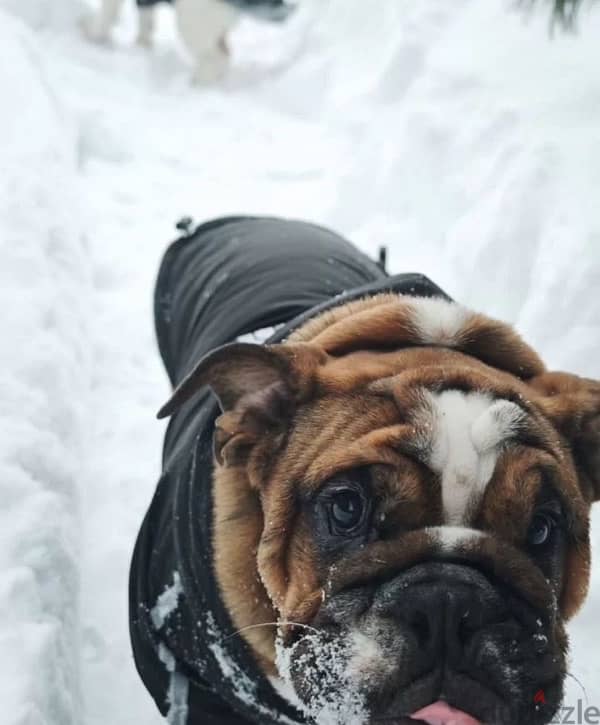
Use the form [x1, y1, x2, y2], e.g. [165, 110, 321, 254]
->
[284, 561, 564, 725]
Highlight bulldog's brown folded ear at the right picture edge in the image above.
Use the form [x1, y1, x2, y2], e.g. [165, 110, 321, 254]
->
[529, 372, 600, 501]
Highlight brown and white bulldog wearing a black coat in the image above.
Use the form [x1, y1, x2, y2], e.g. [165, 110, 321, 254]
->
[132, 218, 600, 725]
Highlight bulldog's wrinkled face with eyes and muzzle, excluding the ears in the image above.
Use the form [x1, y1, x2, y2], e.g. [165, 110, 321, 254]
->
[258, 378, 587, 724]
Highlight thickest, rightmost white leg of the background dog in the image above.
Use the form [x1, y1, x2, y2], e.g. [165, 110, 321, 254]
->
[175, 0, 239, 84]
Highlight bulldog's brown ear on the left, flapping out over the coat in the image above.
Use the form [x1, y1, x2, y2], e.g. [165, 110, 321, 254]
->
[158, 343, 326, 465]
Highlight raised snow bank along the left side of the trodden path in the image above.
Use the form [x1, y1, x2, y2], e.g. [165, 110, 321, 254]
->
[0, 10, 88, 725]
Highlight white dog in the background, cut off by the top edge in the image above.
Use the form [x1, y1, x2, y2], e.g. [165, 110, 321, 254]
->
[82, 0, 295, 84]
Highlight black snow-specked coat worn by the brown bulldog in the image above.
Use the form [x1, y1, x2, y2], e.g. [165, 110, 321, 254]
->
[130, 217, 446, 725]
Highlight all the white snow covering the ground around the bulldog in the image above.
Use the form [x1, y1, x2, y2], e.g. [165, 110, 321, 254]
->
[0, 0, 600, 725]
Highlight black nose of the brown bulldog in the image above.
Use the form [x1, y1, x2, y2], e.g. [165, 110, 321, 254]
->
[374, 563, 504, 664]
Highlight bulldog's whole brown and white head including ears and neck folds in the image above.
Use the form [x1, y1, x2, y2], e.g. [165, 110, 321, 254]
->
[158, 295, 600, 725]
